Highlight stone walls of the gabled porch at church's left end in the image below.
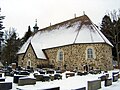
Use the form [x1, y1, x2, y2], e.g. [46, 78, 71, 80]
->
[18, 44, 48, 68]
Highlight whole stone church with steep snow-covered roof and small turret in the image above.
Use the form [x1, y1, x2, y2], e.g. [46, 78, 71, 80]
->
[17, 15, 113, 70]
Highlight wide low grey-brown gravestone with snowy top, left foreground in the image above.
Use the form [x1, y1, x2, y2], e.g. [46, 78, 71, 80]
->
[18, 77, 36, 86]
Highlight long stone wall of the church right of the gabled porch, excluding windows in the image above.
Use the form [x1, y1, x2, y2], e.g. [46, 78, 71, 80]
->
[45, 44, 113, 70]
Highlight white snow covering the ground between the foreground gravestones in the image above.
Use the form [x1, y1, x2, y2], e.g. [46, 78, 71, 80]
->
[3, 70, 120, 90]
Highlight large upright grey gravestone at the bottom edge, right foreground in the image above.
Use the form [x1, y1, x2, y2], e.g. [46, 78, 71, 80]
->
[88, 80, 101, 90]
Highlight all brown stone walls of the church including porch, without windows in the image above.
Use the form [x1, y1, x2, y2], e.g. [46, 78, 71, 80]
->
[19, 43, 113, 70]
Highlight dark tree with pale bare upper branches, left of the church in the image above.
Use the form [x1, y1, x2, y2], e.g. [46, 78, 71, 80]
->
[2, 28, 20, 65]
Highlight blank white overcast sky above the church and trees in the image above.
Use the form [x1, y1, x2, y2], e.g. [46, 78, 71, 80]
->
[0, 0, 120, 37]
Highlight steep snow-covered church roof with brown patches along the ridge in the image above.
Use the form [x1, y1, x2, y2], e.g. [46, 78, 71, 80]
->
[18, 15, 113, 59]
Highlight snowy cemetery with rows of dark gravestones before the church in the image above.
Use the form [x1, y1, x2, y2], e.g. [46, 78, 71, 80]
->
[0, 65, 120, 90]
